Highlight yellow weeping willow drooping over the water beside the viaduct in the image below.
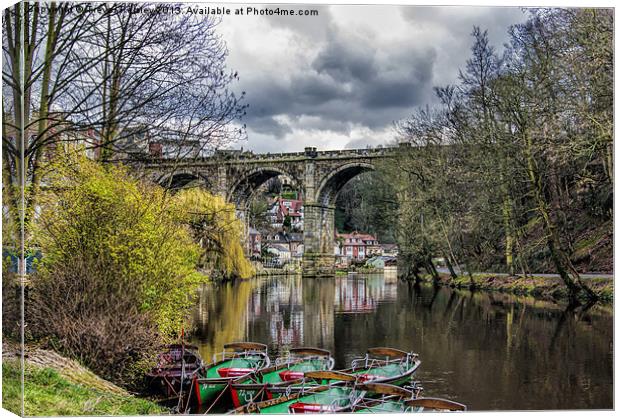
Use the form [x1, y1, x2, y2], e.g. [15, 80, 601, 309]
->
[174, 189, 254, 279]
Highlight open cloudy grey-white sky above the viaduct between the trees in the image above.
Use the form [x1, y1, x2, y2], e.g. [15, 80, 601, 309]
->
[214, 4, 526, 152]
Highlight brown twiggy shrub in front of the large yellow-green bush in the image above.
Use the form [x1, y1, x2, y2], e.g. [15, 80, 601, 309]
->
[26, 257, 164, 387]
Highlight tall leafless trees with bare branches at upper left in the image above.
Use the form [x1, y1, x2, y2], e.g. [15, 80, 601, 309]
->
[2, 2, 246, 242]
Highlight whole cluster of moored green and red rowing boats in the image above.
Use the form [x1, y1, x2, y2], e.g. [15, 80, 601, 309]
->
[149, 342, 465, 413]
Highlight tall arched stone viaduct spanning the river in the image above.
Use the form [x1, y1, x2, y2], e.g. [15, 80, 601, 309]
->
[144, 144, 408, 276]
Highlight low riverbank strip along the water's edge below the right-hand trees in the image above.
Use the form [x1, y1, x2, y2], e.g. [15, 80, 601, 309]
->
[422, 273, 614, 303]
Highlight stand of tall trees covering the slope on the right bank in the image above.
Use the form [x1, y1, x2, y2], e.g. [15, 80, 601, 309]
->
[386, 9, 613, 302]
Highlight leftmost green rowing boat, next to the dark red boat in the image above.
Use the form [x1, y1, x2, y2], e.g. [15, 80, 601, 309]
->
[186, 342, 270, 409]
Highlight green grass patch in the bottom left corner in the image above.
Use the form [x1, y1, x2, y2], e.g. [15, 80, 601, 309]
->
[2, 360, 166, 416]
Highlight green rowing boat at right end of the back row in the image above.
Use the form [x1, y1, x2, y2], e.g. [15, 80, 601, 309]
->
[342, 347, 422, 386]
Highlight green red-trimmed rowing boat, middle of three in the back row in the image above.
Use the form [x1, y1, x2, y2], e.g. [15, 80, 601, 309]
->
[230, 347, 334, 408]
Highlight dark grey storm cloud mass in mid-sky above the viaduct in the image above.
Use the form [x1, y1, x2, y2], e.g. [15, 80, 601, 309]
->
[240, 22, 435, 137]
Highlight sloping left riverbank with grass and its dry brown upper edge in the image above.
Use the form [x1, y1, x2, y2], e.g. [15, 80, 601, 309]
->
[2, 341, 167, 416]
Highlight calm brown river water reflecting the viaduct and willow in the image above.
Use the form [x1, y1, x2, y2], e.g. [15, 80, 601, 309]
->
[192, 275, 613, 410]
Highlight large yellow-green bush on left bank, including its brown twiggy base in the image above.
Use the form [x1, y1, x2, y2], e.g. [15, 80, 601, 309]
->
[26, 156, 202, 386]
